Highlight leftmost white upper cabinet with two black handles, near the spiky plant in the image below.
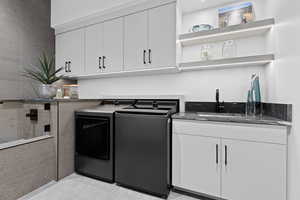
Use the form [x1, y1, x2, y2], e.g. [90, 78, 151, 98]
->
[56, 29, 84, 76]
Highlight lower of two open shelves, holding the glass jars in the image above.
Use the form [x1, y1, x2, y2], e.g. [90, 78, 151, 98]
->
[179, 54, 275, 71]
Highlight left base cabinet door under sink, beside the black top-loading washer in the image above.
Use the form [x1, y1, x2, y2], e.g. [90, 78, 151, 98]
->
[172, 134, 221, 197]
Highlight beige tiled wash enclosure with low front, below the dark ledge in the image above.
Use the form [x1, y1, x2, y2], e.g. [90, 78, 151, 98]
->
[0, 102, 58, 200]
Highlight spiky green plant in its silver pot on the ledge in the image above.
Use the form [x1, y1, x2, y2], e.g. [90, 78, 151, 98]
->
[23, 53, 63, 98]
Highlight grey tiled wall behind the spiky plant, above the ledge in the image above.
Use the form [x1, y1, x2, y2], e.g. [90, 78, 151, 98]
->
[0, 0, 55, 99]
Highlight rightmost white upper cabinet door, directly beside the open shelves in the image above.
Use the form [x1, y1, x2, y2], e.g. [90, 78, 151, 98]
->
[147, 3, 176, 68]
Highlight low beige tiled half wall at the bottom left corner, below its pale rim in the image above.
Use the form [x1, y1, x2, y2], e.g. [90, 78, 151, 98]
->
[0, 138, 56, 200]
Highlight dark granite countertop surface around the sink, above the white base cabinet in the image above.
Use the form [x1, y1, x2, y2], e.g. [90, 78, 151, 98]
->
[172, 112, 292, 126]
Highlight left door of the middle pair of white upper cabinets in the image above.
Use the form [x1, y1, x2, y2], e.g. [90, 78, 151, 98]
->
[85, 24, 104, 74]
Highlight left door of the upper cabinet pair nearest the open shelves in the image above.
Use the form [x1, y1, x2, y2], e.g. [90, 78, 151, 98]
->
[124, 11, 148, 71]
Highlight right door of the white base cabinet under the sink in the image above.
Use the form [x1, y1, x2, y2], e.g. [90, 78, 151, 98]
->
[221, 139, 286, 200]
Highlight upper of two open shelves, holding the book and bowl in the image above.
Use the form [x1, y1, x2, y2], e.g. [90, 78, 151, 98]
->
[179, 18, 275, 46]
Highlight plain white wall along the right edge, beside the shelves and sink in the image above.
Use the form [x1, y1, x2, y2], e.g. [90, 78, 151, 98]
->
[266, 0, 300, 200]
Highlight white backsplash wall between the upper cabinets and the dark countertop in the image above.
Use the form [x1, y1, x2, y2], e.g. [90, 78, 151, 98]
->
[79, 67, 266, 101]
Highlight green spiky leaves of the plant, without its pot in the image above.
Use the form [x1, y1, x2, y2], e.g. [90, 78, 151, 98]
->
[23, 53, 63, 85]
